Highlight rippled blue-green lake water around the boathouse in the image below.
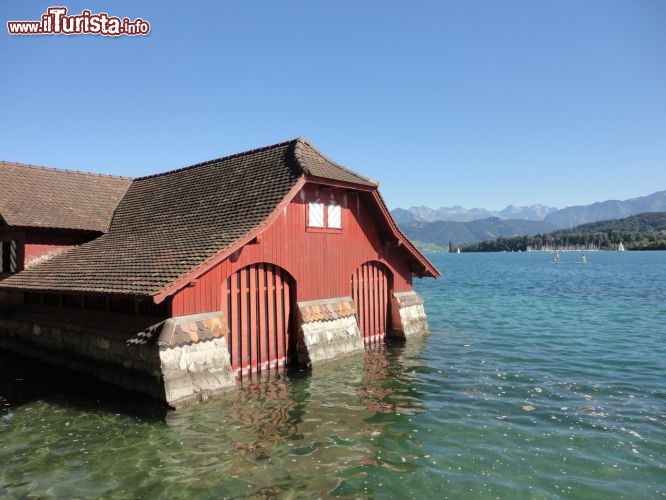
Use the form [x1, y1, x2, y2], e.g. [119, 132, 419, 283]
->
[0, 252, 666, 499]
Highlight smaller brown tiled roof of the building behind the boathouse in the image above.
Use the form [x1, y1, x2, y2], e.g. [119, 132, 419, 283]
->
[0, 161, 132, 232]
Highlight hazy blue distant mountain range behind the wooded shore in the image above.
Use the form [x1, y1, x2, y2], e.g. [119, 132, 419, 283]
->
[392, 191, 666, 248]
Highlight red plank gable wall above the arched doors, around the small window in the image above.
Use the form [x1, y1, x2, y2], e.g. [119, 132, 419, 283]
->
[172, 185, 412, 316]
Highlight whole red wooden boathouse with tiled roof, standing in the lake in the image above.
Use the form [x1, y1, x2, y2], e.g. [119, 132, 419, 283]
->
[0, 139, 439, 406]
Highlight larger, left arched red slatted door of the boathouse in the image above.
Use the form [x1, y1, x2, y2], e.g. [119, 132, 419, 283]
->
[222, 263, 296, 377]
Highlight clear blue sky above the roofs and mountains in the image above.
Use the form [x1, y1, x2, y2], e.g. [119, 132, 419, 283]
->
[0, 0, 666, 210]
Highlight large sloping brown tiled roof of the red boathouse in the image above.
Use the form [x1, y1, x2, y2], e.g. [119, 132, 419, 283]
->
[0, 139, 384, 296]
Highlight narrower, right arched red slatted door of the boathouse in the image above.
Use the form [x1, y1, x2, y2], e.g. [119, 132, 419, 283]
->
[351, 261, 393, 345]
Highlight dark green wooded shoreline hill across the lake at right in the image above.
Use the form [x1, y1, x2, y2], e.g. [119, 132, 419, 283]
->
[449, 212, 666, 252]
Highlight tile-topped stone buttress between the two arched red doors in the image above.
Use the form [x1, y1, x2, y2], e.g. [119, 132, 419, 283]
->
[297, 297, 364, 366]
